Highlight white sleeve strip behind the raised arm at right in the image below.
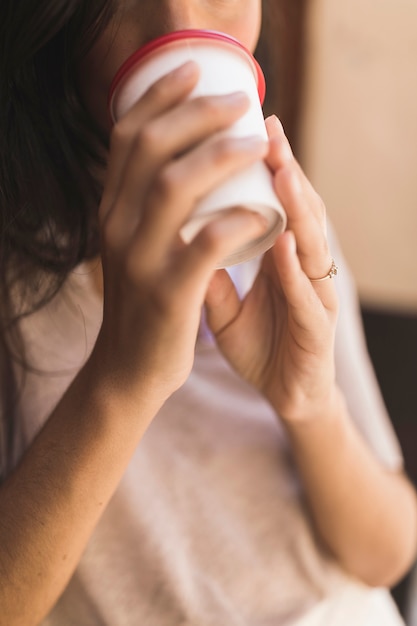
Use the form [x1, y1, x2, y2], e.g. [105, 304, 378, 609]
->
[329, 226, 403, 470]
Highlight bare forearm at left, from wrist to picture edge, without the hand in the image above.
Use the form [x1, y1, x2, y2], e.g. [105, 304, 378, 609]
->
[0, 359, 159, 626]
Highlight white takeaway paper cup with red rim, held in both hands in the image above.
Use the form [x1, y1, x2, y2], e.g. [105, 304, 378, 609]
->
[109, 30, 286, 267]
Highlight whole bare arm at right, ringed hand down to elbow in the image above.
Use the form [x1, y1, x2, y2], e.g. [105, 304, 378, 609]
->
[206, 118, 417, 585]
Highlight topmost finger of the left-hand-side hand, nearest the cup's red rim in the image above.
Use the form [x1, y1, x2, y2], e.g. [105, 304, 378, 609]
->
[100, 61, 199, 219]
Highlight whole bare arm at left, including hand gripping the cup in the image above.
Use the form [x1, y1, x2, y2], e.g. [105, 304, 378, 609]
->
[0, 64, 268, 626]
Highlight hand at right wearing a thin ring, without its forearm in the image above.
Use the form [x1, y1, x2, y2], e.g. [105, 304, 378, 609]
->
[206, 117, 338, 421]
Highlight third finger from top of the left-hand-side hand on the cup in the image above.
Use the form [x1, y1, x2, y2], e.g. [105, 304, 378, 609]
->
[134, 137, 268, 263]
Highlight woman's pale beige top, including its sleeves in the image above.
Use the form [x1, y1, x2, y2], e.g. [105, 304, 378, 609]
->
[12, 228, 402, 626]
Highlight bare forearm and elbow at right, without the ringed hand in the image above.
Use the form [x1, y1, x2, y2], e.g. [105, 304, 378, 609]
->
[287, 390, 417, 586]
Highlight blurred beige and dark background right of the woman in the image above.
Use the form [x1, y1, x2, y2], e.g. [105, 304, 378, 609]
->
[272, 0, 417, 626]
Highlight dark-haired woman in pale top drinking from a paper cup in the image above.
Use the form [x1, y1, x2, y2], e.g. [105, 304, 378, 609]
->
[0, 0, 416, 626]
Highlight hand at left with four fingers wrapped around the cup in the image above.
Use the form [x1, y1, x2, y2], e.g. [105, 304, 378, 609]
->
[92, 62, 268, 404]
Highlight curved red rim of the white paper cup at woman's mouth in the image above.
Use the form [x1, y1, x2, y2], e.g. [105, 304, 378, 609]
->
[108, 29, 266, 116]
